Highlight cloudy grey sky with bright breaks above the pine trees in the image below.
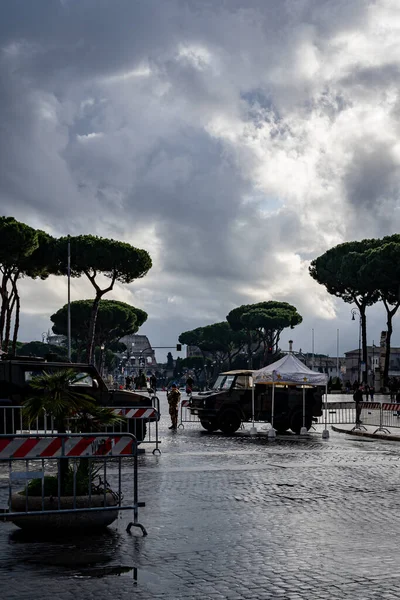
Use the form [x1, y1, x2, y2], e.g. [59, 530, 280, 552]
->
[0, 0, 400, 358]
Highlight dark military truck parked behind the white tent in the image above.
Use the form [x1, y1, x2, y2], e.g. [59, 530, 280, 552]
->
[188, 370, 322, 434]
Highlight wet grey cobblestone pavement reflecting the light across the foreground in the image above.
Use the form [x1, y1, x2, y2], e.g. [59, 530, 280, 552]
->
[0, 392, 400, 600]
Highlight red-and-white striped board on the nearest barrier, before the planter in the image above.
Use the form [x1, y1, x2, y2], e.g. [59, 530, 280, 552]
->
[0, 435, 134, 460]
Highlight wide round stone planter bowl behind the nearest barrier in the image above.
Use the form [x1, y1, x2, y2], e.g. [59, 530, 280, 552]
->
[10, 493, 118, 532]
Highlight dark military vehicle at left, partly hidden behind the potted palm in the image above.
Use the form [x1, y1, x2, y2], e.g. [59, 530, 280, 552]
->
[0, 354, 156, 441]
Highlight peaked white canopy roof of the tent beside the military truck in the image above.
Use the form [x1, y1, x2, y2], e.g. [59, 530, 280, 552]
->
[253, 354, 328, 386]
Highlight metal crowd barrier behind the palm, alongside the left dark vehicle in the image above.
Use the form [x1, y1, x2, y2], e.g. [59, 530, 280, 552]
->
[0, 396, 161, 454]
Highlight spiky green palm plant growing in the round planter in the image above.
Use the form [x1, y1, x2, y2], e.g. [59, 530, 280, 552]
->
[22, 369, 122, 492]
